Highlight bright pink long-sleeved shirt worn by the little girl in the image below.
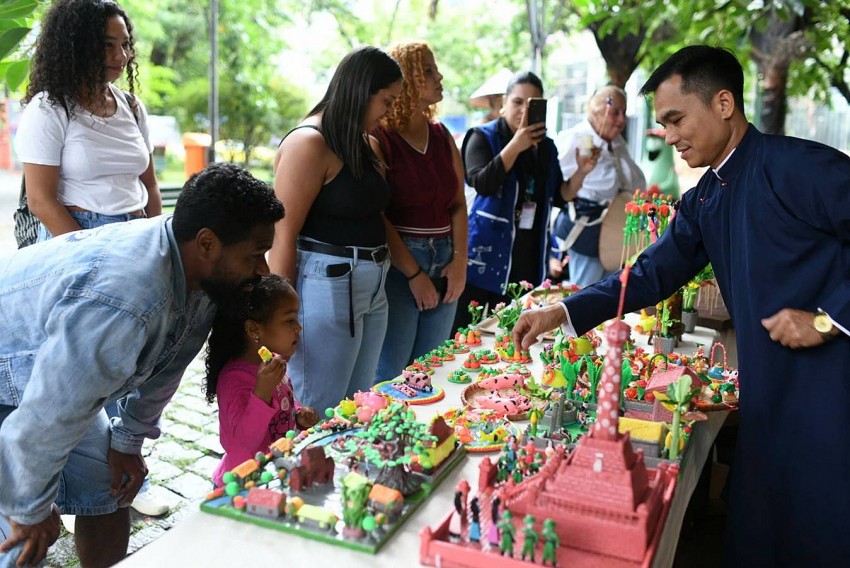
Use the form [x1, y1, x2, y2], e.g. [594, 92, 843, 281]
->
[213, 359, 299, 487]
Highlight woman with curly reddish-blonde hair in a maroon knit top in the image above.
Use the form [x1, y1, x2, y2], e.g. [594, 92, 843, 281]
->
[373, 43, 467, 381]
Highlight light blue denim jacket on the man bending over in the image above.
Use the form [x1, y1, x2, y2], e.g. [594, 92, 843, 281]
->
[0, 216, 214, 524]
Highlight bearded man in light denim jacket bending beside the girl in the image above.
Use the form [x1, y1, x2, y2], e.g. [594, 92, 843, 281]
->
[0, 164, 283, 567]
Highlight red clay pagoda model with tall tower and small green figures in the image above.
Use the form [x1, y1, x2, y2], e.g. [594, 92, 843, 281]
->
[420, 270, 680, 568]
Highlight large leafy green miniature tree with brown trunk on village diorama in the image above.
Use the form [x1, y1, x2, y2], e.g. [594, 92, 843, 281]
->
[347, 403, 437, 495]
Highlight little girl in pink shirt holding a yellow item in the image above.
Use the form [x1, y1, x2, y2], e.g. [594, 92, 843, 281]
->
[204, 274, 318, 487]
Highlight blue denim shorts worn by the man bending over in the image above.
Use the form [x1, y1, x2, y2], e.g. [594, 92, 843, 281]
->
[0, 405, 118, 520]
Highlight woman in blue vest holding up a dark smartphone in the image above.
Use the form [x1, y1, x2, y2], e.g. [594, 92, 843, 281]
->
[454, 71, 572, 327]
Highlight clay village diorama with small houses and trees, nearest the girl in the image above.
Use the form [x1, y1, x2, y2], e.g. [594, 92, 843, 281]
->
[201, 402, 465, 553]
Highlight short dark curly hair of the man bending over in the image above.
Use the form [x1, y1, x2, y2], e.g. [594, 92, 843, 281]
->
[172, 163, 284, 245]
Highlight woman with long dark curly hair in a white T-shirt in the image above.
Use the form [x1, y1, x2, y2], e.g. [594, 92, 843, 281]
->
[15, 0, 162, 240]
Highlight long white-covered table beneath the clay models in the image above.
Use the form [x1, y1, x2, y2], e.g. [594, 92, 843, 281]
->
[120, 322, 726, 568]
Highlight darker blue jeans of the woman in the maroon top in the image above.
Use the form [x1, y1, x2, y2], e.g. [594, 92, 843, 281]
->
[375, 237, 457, 382]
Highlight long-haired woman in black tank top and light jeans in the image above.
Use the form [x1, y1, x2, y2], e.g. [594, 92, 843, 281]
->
[269, 47, 401, 410]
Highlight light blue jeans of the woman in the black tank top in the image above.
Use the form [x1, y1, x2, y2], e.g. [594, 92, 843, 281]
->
[287, 241, 390, 416]
